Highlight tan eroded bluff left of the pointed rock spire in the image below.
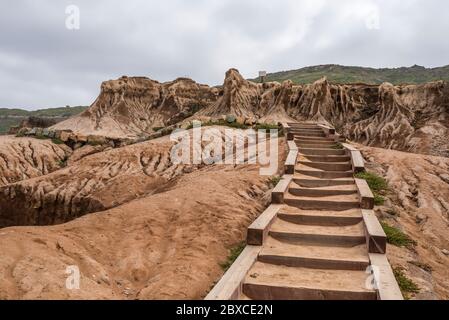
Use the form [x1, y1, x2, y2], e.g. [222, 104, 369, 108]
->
[51, 77, 218, 139]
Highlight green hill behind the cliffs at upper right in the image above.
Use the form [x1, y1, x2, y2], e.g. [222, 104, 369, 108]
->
[253, 65, 449, 85]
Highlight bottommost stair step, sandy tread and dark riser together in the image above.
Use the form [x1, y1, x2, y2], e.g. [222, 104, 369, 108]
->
[243, 262, 377, 300]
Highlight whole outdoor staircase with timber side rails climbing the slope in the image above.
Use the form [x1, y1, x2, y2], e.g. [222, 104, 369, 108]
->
[207, 123, 402, 300]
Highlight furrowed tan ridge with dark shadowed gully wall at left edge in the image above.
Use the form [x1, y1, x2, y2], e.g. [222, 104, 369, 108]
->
[0, 143, 184, 228]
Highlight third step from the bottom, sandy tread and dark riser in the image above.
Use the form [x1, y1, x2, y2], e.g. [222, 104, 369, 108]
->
[269, 218, 366, 247]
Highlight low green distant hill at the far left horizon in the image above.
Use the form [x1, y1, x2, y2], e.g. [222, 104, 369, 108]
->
[0, 106, 88, 134]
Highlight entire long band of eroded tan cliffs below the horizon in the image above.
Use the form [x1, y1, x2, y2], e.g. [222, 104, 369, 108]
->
[52, 69, 449, 156]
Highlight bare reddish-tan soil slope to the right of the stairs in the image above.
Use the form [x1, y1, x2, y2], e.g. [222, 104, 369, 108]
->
[359, 146, 449, 299]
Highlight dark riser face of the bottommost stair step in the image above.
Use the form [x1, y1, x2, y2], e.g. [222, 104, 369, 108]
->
[243, 283, 377, 300]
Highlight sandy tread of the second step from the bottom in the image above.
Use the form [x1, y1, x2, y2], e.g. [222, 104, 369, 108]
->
[260, 237, 369, 263]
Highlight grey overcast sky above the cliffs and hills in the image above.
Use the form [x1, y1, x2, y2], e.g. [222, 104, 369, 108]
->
[0, 0, 449, 109]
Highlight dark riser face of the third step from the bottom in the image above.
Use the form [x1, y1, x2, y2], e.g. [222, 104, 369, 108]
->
[270, 231, 366, 247]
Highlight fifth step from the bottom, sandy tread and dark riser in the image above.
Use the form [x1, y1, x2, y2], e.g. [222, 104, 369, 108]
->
[284, 193, 360, 211]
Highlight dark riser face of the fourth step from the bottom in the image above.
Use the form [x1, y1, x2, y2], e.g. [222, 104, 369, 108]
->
[278, 213, 362, 227]
